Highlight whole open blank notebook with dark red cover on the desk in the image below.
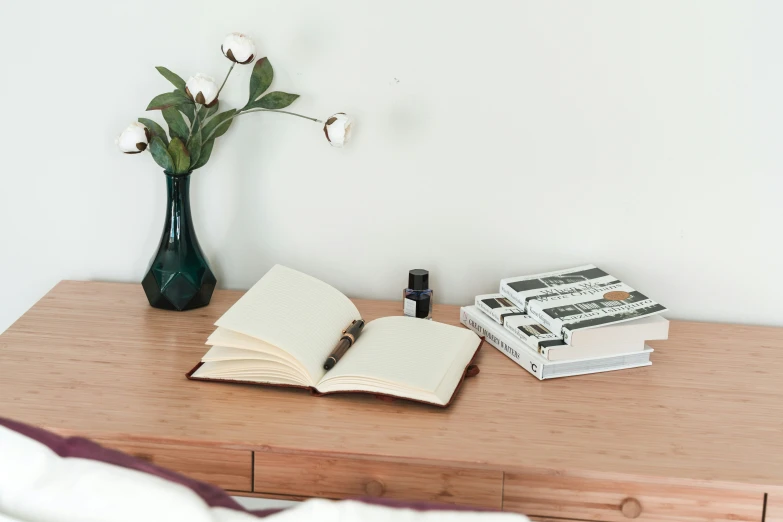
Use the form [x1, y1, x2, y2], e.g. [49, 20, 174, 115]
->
[188, 265, 481, 406]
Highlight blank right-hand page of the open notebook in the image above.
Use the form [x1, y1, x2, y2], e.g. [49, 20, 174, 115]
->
[323, 317, 479, 392]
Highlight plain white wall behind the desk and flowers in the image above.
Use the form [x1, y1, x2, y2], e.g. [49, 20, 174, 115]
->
[0, 0, 783, 330]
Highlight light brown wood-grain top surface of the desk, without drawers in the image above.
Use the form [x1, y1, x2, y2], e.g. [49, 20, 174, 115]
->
[0, 281, 783, 492]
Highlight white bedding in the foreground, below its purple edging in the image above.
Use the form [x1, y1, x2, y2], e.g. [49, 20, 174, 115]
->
[0, 426, 527, 522]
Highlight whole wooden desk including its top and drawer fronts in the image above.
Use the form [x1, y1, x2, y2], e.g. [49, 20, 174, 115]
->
[0, 281, 783, 522]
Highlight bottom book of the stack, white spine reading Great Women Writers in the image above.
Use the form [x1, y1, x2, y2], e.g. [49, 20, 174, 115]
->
[460, 306, 653, 380]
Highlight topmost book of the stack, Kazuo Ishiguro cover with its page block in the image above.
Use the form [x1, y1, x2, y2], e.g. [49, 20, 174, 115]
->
[500, 265, 669, 346]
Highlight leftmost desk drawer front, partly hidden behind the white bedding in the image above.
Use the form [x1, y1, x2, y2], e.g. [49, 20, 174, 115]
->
[96, 440, 253, 491]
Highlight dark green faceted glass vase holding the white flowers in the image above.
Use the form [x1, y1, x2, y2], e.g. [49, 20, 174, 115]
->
[141, 173, 217, 311]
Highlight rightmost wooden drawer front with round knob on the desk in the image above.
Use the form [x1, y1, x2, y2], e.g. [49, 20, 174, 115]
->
[503, 471, 764, 522]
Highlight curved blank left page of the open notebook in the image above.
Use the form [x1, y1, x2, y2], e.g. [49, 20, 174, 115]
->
[215, 265, 361, 383]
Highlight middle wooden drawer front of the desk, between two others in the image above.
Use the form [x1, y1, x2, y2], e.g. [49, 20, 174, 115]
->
[254, 451, 503, 509]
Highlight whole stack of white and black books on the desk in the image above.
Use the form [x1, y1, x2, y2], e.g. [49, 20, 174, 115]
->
[460, 265, 669, 379]
